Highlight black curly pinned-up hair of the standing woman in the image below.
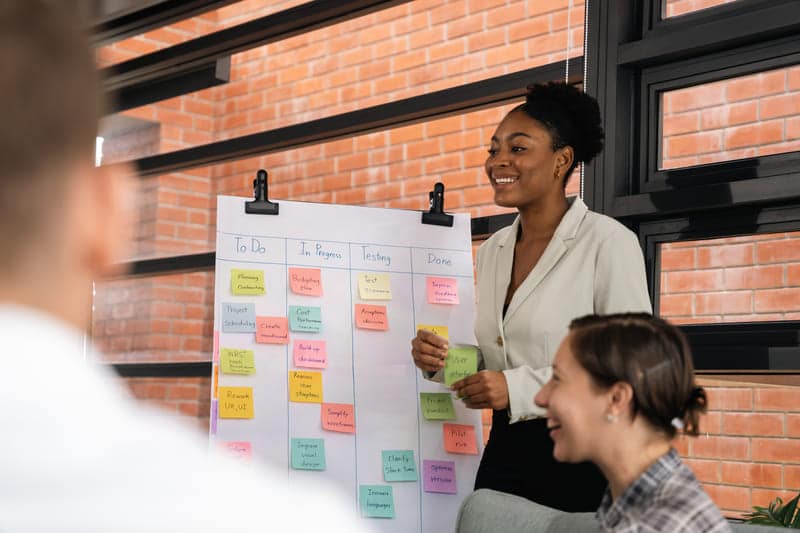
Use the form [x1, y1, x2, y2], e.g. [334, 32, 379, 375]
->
[514, 82, 605, 186]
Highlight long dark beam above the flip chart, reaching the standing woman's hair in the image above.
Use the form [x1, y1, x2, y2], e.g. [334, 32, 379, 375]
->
[131, 58, 583, 177]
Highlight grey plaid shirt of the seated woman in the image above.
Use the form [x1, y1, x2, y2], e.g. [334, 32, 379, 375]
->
[597, 449, 731, 533]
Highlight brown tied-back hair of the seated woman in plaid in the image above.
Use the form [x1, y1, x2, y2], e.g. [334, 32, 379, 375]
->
[570, 313, 707, 438]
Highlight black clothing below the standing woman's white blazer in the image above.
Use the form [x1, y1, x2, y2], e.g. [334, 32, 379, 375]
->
[475, 409, 607, 512]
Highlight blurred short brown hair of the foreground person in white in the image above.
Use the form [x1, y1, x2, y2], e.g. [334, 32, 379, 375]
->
[0, 0, 103, 268]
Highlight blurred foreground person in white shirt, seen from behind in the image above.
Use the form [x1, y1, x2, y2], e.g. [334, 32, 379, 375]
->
[0, 0, 376, 533]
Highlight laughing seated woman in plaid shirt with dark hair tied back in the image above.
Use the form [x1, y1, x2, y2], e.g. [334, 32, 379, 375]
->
[534, 313, 730, 532]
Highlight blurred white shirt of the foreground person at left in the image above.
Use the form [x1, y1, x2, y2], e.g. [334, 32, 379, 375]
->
[0, 306, 371, 533]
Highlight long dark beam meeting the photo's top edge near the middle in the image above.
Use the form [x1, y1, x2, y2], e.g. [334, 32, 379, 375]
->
[101, 0, 409, 91]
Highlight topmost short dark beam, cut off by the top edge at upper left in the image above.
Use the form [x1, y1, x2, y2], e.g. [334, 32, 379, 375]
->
[89, 0, 238, 46]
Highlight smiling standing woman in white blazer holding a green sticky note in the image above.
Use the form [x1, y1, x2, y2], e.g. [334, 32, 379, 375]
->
[411, 83, 651, 511]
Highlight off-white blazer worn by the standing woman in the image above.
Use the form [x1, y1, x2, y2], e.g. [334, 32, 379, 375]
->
[475, 197, 651, 424]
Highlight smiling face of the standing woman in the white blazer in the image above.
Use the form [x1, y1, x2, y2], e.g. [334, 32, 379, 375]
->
[485, 109, 569, 209]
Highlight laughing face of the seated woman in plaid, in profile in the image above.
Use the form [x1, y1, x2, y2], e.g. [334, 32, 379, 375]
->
[534, 333, 612, 463]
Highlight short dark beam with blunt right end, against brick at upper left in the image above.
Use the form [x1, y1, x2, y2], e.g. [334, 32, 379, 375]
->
[108, 57, 231, 113]
